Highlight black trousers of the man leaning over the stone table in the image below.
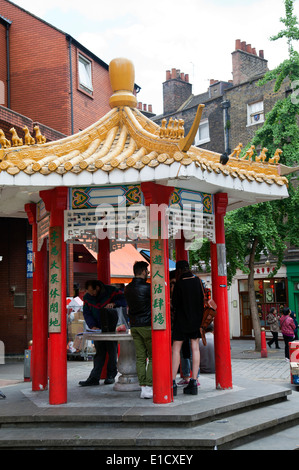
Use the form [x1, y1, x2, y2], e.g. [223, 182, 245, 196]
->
[89, 341, 118, 380]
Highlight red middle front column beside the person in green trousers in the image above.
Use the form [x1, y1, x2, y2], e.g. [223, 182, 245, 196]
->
[141, 182, 173, 404]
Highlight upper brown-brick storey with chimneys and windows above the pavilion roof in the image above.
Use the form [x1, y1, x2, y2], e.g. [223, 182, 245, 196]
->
[153, 39, 288, 153]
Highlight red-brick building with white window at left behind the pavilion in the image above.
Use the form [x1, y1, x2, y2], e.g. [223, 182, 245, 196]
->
[0, 0, 138, 354]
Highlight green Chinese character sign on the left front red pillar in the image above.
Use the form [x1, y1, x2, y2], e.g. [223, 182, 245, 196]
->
[49, 227, 61, 333]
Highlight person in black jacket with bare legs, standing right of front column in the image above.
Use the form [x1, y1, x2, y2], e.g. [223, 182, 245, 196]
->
[172, 260, 204, 396]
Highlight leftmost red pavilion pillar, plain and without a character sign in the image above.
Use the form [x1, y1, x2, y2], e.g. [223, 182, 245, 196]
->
[25, 204, 48, 391]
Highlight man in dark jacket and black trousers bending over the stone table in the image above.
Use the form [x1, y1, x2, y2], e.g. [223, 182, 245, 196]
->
[79, 280, 126, 387]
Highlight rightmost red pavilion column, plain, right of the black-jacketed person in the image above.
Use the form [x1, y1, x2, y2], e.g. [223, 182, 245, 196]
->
[211, 193, 232, 390]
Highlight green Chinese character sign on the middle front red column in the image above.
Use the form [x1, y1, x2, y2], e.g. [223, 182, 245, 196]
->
[151, 238, 166, 330]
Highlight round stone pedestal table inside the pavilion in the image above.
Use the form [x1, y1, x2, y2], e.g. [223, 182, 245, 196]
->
[82, 330, 140, 392]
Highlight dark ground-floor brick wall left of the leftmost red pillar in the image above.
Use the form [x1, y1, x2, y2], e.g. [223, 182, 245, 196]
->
[0, 218, 32, 354]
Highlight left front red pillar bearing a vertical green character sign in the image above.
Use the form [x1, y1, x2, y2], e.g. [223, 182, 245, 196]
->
[40, 187, 68, 405]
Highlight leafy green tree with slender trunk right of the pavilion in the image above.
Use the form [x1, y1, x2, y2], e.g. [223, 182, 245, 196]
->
[190, 0, 299, 351]
